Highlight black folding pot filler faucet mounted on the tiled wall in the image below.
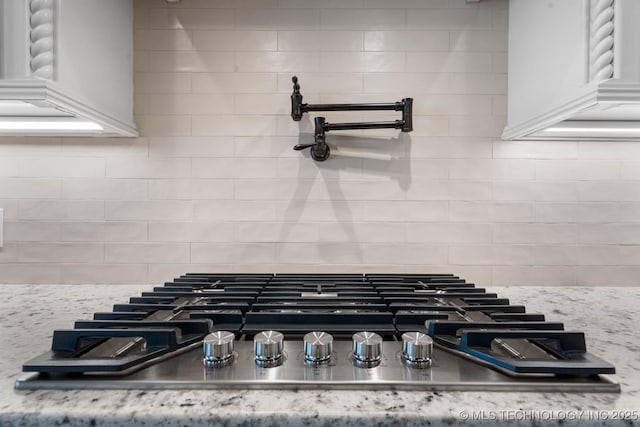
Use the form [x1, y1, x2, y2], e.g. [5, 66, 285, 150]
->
[291, 76, 413, 162]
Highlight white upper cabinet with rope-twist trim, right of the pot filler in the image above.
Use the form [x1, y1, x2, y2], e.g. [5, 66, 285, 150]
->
[503, 0, 640, 139]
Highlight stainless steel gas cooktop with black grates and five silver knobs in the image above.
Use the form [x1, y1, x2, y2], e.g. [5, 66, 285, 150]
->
[16, 274, 620, 392]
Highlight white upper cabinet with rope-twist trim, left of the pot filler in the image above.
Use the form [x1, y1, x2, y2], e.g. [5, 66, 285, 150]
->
[0, 0, 137, 136]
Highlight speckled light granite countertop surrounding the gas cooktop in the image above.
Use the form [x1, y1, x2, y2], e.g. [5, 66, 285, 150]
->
[0, 285, 640, 427]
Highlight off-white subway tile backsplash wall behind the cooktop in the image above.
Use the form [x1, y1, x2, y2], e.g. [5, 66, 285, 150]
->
[0, 0, 640, 285]
